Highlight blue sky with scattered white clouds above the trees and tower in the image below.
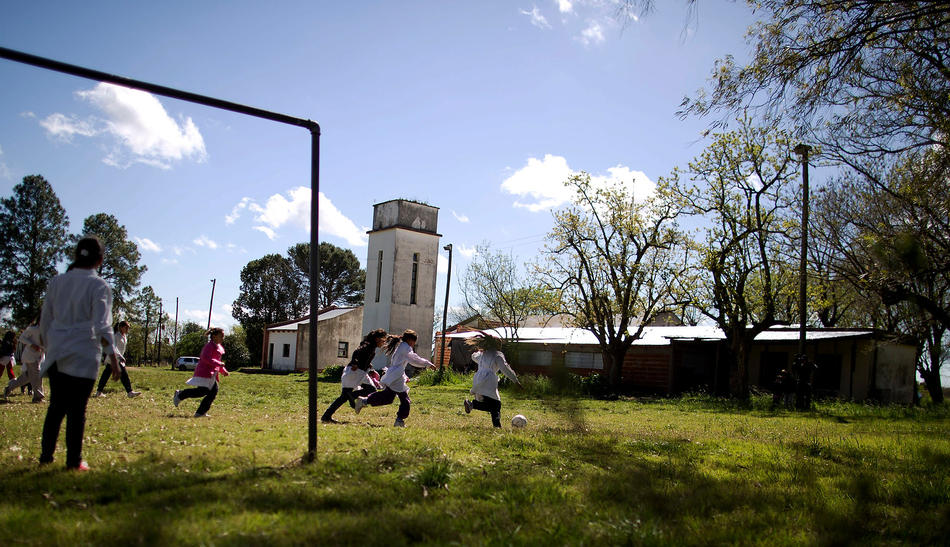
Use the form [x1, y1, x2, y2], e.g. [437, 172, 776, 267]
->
[0, 0, 753, 326]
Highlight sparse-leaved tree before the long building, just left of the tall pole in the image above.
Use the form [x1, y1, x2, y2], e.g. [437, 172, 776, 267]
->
[668, 118, 798, 398]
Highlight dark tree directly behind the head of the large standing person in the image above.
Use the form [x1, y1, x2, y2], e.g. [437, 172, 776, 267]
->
[73, 213, 148, 317]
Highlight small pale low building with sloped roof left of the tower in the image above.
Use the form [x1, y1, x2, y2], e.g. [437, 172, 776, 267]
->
[262, 306, 363, 371]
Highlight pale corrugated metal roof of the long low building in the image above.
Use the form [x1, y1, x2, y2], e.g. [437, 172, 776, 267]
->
[446, 325, 873, 346]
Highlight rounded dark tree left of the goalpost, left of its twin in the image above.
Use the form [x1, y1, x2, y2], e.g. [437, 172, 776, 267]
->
[231, 254, 307, 363]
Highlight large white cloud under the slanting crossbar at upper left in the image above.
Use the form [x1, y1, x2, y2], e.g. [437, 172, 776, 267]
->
[40, 83, 207, 169]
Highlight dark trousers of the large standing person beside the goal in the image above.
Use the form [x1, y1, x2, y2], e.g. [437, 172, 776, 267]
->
[40, 363, 96, 468]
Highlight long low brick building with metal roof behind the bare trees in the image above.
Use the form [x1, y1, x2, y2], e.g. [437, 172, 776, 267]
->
[446, 326, 916, 403]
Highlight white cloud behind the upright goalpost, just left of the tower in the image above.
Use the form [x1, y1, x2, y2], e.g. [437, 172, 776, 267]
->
[240, 186, 367, 247]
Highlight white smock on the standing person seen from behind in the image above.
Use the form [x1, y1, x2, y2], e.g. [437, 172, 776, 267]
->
[40, 268, 115, 380]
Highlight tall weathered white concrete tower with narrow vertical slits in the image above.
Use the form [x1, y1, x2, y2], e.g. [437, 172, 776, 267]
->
[363, 199, 442, 366]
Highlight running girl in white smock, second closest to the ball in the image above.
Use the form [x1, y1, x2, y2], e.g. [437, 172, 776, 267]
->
[353, 329, 435, 427]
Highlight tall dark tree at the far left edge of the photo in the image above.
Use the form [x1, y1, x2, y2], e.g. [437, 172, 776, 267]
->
[0, 175, 69, 328]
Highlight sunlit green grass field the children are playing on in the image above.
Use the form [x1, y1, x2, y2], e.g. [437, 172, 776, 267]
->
[0, 368, 950, 545]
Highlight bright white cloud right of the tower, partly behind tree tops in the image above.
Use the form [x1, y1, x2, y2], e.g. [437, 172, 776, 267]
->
[501, 154, 656, 213]
